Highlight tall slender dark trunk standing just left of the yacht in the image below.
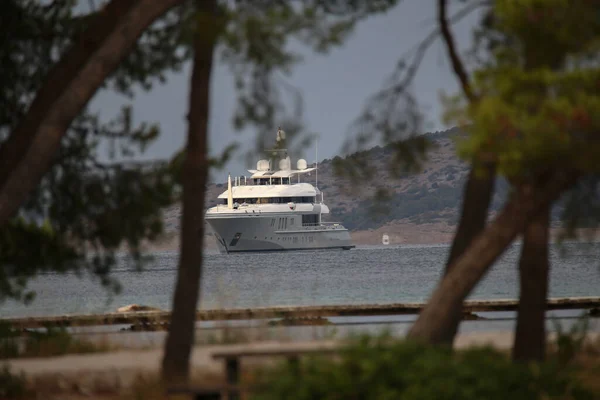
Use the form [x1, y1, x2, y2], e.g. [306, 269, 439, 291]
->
[162, 0, 218, 383]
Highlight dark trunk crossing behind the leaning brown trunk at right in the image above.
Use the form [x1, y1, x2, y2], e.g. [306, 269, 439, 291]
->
[439, 164, 496, 345]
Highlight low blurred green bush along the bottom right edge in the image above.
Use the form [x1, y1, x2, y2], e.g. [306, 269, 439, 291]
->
[253, 335, 594, 400]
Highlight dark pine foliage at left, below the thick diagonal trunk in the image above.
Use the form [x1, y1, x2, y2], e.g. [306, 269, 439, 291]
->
[0, 107, 177, 301]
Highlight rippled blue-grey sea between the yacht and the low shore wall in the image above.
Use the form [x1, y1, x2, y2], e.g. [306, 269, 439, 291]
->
[0, 243, 600, 317]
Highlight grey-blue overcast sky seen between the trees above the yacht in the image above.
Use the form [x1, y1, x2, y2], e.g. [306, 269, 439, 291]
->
[90, 0, 478, 182]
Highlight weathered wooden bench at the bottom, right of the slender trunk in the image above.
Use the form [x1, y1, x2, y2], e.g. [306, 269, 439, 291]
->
[167, 342, 339, 400]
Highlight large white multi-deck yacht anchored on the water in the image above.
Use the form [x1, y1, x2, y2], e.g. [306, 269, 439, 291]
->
[206, 129, 355, 253]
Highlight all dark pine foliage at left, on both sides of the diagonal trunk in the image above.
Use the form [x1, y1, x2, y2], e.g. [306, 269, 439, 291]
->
[0, 0, 189, 301]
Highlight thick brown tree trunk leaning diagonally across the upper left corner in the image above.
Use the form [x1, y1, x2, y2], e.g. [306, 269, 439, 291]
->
[0, 0, 182, 226]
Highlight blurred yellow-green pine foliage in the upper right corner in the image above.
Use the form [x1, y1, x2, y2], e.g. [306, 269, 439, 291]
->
[447, 0, 600, 179]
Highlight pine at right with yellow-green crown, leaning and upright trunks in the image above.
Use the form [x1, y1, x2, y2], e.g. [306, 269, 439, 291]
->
[409, 0, 600, 350]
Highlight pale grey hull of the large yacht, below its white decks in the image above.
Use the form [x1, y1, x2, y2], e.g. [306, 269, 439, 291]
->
[206, 213, 354, 253]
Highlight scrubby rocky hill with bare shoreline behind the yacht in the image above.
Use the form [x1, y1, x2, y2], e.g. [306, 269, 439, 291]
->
[151, 128, 596, 249]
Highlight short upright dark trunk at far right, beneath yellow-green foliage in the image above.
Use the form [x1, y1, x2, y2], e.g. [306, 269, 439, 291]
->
[512, 207, 550, 361]
